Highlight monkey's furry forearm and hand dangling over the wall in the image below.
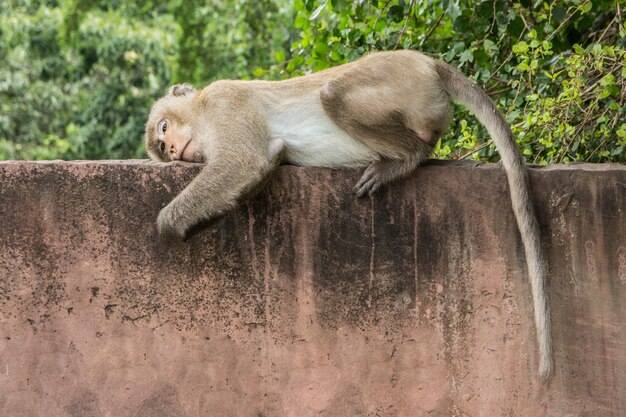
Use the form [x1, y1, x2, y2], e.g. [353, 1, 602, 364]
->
[157, 139, 284, 241]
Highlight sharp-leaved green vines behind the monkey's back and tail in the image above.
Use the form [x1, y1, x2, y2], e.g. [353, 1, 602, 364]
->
[284, 0, 626, 163]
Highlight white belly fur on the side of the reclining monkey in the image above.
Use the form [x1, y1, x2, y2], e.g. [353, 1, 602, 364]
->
[266, 93, 378, 167]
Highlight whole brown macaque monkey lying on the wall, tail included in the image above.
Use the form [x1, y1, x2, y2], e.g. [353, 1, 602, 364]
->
[145, 51, 553, 379]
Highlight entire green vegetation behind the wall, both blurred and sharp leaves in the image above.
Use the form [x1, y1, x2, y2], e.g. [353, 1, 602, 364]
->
[0, 0, 626, 163]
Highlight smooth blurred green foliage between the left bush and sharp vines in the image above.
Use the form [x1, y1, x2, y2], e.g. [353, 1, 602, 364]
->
[171, 0, 292, 85]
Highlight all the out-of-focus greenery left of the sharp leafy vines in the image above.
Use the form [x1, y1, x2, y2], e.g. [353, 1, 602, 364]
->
[0, 0, 291, 159]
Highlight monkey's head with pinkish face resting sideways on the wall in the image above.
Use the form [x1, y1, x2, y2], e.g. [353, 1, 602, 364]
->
[145, 84, 205, 162]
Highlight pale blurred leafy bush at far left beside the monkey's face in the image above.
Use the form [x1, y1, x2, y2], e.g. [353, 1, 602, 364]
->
[0, 2, 176, 159]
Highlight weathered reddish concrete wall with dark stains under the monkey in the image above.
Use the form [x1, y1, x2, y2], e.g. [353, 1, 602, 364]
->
[0, 161, 626, 417]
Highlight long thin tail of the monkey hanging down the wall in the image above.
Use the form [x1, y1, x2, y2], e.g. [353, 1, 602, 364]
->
[435, 61, 553, 380]
